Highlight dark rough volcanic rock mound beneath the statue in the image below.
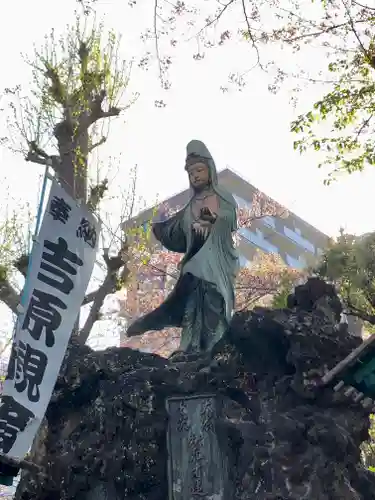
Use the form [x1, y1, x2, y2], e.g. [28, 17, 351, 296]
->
[16, 281, 375, 500]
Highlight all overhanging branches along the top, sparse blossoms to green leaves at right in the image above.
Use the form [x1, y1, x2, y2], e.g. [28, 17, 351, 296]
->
[131, 0, 375, 176]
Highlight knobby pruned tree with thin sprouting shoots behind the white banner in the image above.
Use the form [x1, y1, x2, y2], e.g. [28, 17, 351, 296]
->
[0, 12, 142, 343]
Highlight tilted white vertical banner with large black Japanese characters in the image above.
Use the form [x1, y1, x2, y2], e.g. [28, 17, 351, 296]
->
[0, 181, 100, 459]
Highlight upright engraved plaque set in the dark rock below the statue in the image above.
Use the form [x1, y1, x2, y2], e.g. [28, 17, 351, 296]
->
[167, 394, 230, 500]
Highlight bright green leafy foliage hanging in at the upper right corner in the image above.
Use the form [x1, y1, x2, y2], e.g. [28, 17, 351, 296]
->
[284, 0, 375, 184]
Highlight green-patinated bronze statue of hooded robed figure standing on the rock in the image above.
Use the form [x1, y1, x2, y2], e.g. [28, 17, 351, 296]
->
[127, 140, 238, 353]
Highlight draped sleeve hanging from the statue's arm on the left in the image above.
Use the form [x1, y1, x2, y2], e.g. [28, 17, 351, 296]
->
[152, 210, 187, 253]
